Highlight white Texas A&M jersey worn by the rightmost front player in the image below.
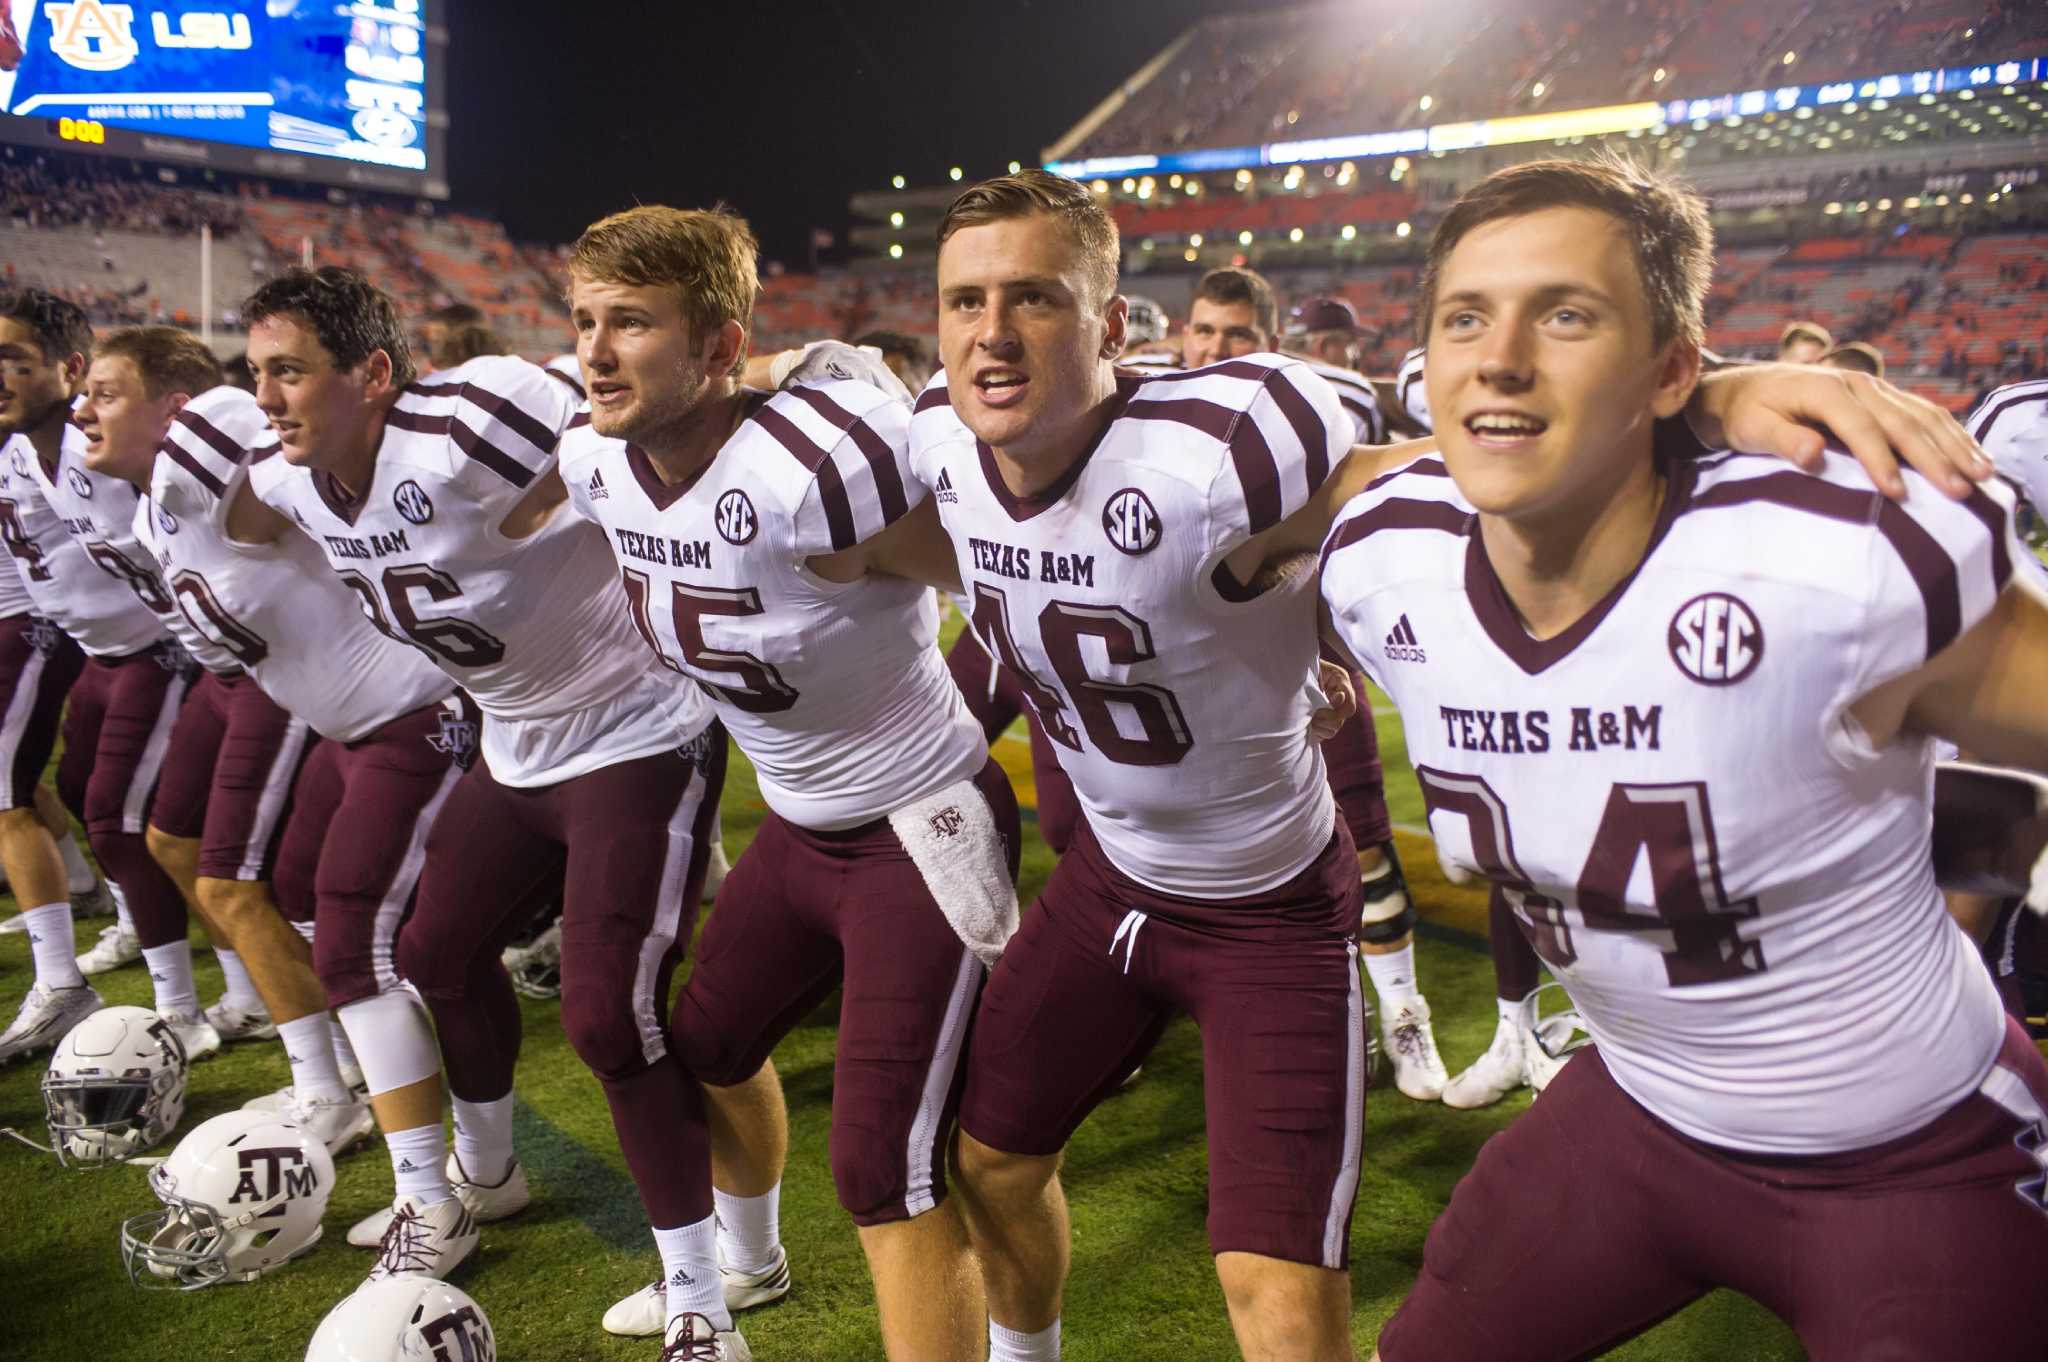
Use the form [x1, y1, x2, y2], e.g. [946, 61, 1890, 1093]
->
[1321, 455, 2019, 1155]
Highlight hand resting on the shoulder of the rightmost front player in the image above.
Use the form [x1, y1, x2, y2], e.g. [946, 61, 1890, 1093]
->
[1686, 365, 1991, 502]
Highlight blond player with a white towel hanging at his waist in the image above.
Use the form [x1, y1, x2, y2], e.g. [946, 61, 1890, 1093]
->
[561, 207, 1018, 1358]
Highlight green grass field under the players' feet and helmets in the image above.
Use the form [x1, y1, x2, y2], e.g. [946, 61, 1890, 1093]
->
[0, 663, 1802, 1362]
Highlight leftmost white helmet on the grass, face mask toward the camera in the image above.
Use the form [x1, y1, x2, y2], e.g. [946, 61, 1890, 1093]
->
[43, 1008, 186, 1167]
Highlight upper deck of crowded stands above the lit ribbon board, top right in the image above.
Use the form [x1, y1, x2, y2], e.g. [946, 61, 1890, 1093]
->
[1065, 0, 2048, 158]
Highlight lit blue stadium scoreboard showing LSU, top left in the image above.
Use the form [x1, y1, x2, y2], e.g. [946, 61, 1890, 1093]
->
[0, 0, 449, 199]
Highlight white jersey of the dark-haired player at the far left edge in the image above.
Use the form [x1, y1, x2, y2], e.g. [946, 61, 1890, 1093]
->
[0, 426, 164, 657]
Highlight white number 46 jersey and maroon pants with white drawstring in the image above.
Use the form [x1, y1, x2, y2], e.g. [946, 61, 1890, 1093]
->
[911, 354, 1364, 1268]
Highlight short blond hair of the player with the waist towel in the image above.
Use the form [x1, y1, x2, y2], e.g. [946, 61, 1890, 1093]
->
[569, 203, 760, 377]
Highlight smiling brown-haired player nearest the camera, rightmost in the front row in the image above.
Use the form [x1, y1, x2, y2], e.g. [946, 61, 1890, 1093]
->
[1321, 160, 2048, 1362]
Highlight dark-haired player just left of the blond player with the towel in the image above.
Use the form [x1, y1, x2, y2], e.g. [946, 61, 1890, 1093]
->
[242, 268, 780, 1327]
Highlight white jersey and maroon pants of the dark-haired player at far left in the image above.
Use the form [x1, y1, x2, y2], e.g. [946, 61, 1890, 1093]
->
[0, 424, 193, 948]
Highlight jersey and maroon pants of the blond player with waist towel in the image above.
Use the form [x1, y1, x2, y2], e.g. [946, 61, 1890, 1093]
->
[561, 381, 1018, 1225]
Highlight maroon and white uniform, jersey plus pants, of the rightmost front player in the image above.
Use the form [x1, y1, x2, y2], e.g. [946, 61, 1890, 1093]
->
[1321, 455, 2048, 1362]
